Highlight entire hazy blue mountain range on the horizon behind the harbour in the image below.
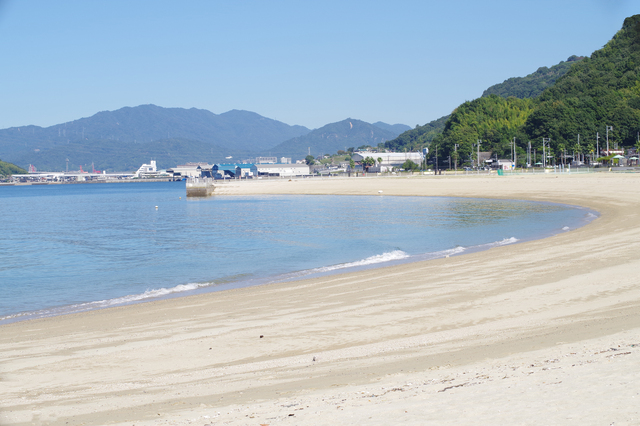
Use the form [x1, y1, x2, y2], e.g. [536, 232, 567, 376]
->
[0, 105, 410, 171]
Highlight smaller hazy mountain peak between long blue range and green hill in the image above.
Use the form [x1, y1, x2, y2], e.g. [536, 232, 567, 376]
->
[263, 118, 397, 159]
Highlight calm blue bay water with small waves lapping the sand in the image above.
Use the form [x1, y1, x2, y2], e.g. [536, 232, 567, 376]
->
[0, 182, 596, 322]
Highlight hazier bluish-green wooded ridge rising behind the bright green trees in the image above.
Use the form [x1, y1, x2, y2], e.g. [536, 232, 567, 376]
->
[482, 55, 584, 99]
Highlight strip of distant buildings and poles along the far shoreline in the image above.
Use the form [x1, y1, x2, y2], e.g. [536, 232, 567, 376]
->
[9, 141, 638, 183]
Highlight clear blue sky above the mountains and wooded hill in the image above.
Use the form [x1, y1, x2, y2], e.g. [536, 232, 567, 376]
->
[0, 0, 640, 128]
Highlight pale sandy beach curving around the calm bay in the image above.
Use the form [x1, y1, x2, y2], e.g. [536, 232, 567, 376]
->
[0, 173, 640, 426]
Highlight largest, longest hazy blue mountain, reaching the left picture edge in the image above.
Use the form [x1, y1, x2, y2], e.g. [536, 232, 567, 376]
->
[0, 105, 310, 170]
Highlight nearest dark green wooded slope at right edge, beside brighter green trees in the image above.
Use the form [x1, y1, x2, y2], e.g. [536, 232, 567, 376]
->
[525, 15, 640, 148]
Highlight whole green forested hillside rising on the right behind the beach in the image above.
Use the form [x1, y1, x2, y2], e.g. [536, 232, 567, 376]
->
[387, 15, 640, 164]
